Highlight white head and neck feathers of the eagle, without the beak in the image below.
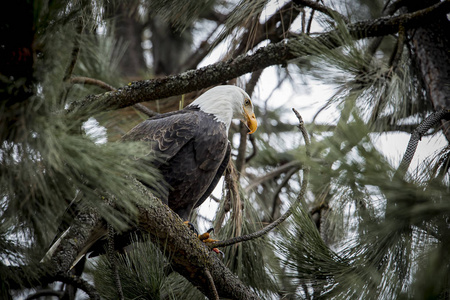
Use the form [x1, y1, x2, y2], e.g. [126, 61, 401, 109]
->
[190, 85, 249, 131]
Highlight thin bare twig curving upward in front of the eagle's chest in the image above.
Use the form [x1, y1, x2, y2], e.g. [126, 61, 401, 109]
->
[208, 109, 309, 248]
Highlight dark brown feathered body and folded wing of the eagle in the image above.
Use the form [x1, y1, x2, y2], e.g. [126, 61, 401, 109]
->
[122, 107, 230, 220]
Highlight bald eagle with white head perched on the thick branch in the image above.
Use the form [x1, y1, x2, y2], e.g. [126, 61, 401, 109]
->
[43, 85, 257, 265]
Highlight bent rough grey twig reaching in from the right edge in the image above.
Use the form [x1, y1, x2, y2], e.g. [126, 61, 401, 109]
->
[394, 109, 450, 178]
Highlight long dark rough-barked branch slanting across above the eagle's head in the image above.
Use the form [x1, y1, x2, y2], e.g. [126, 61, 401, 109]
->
[69, 1, 450, 112]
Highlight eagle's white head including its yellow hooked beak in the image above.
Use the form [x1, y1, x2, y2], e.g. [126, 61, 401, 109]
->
[190, 85, 258, 133]
